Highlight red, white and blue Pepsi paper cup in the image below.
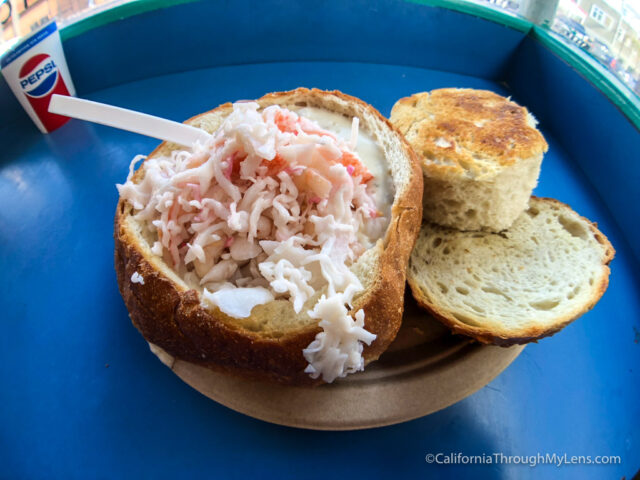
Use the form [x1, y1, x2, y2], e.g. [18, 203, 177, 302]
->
[0, 22, 75, 133]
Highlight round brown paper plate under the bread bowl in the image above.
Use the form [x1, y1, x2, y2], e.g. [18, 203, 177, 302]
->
[151, 292, 524, 430]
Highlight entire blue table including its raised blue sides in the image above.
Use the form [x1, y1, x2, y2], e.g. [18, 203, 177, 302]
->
[0, 0, 640, 479]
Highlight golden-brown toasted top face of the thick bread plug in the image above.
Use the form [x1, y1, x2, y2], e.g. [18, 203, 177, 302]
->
[391, 88, 548, 178]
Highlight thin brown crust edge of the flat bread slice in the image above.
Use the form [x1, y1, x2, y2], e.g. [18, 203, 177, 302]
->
[407, 197, 615, 347]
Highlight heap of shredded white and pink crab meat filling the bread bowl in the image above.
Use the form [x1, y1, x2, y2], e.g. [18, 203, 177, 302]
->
[117, 102, 387, 382]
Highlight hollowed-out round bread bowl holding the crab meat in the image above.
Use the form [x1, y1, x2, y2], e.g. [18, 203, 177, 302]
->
[114, 88, 422, 385]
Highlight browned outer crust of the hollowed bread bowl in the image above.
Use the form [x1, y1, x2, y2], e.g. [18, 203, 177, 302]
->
[114, 88, 422, 385]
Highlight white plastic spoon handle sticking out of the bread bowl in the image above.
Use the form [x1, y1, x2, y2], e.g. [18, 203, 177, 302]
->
[49, 95, 210, 147]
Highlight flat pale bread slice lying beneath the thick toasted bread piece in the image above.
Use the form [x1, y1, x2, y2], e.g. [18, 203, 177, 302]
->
[407, 197, 615, 346]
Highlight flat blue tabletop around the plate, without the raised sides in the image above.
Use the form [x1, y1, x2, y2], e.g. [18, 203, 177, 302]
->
[0, 62, 640, 479]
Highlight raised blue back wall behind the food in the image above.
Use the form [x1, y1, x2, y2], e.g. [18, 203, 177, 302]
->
[0, 0, 525, 128]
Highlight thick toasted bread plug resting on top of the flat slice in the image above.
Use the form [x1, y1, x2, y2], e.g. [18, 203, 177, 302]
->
[391, 88, 548, 232]
